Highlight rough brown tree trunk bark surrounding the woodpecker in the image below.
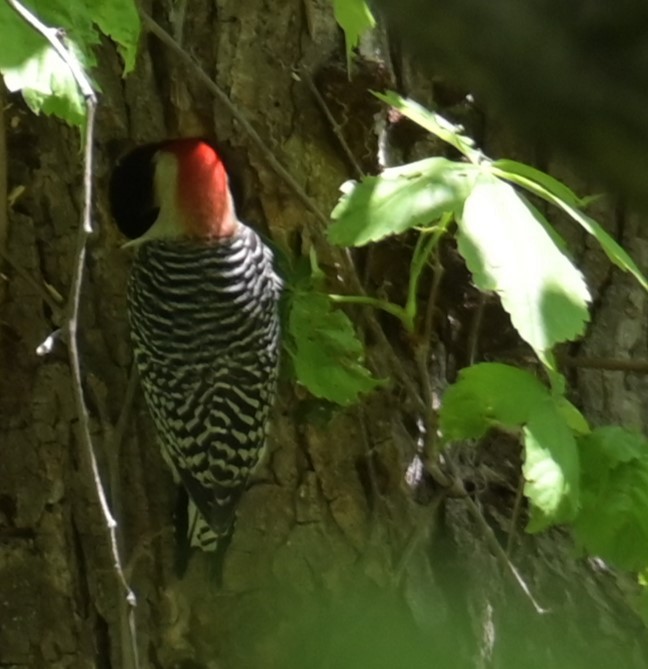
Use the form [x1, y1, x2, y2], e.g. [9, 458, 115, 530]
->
[0, 0, 648, 669]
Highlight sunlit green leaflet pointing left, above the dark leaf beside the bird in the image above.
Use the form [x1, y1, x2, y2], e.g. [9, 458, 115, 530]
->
[328, 158, 477, 246]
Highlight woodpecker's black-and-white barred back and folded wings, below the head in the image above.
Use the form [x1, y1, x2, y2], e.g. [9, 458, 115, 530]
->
[128, 226, 280, 547]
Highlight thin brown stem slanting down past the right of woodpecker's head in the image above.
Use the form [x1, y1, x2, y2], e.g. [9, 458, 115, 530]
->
[140, 8, 423, 410]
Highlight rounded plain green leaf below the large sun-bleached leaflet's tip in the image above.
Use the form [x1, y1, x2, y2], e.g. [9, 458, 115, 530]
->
[439, 362, 550, 441]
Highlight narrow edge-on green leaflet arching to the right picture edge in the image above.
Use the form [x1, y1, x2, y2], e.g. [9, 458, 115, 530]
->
[492, 160, 648, 290]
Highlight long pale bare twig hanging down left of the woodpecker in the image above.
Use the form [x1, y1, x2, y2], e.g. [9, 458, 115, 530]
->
[6, 0, 139, 669]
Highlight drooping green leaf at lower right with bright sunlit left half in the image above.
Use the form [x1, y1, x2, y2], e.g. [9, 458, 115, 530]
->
[522, 398, 580, 532]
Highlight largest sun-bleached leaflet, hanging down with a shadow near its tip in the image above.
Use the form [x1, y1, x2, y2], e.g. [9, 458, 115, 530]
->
[458, 174, 590, 359]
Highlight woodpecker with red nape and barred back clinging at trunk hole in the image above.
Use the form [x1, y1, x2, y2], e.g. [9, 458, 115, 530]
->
[110, 139, 281, 550]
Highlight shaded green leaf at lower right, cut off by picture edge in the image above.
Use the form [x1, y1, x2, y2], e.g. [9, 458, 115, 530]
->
[574, 427, 648, 570]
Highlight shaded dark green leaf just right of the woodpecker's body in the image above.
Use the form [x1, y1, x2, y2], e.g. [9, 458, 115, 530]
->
[288, 291, 380, 406]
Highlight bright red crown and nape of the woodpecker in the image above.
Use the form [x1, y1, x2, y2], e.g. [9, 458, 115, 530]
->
[164, 139, 237, 238]
